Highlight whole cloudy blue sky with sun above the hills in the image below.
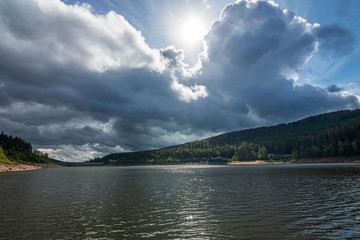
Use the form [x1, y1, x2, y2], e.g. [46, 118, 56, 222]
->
[0, 0, 360, 161]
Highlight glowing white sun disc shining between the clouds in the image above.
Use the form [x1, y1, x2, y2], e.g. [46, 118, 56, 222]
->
[179, 16, 206, 45]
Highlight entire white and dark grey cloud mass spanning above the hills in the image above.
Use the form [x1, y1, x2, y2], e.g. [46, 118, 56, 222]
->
[0, 0, 359, 161]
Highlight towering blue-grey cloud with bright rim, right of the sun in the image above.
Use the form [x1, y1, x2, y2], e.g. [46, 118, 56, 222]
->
[198, 1, 358, 124]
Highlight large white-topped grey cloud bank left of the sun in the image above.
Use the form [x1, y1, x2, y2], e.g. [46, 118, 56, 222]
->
[0, 0, 206, 160]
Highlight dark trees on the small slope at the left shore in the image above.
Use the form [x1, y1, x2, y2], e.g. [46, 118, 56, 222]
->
[0, 132, 50, 163]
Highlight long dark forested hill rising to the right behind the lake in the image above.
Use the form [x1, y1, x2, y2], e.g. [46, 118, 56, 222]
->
[92, 109, 360, 164]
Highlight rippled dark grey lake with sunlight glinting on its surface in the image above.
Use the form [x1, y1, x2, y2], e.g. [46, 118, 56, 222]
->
[0, 164, 360, 239]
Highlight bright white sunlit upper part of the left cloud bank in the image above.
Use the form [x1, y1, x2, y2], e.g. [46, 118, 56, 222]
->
[0, 0, 165, 72]
